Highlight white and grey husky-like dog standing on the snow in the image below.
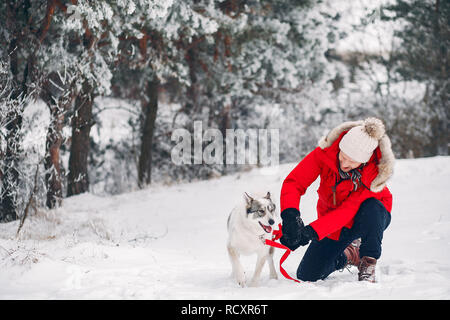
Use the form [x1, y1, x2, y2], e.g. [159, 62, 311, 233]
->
[227, 192, 278, 287]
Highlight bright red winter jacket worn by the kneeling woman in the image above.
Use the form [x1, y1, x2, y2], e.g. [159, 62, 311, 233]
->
[280, 127, 393, 240]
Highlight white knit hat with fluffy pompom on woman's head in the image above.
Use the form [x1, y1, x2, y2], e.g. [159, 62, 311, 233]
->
[339, 118, 385, 163]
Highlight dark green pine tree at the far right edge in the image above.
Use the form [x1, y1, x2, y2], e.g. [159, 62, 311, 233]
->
[381, 0, 450, 155]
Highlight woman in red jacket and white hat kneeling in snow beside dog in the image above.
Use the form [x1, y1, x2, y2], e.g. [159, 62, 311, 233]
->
[280, 118, 395, 282]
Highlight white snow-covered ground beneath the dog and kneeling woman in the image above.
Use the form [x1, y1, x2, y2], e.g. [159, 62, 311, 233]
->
[0, 157, 450, 299]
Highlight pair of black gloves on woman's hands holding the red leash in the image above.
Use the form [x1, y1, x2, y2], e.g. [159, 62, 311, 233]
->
[280, 208, 318, 251]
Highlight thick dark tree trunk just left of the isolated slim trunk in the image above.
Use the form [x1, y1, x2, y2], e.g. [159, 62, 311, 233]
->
[67, 81, 94, 197]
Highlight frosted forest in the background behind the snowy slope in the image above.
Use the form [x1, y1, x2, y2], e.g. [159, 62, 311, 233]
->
[0, 0, 450, 222]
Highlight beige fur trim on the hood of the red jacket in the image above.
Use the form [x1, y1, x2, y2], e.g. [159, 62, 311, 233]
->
[319, 120, 395, 192]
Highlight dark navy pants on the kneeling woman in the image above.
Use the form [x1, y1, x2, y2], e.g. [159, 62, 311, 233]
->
[297, 198, 391, 281]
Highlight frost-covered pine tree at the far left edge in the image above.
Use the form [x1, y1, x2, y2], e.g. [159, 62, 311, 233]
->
[0, 0, 55, 221]
